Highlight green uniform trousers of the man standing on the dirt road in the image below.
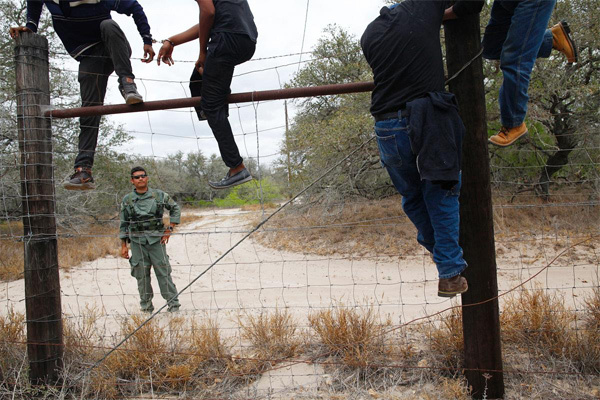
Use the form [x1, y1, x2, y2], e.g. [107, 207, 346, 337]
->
[129, 242, 180, 312]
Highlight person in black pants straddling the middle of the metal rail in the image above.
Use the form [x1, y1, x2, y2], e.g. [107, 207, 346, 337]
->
[157, 0, 258, 189]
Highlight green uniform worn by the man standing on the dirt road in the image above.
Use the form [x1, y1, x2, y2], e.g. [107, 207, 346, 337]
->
[119, 188, 181, 312]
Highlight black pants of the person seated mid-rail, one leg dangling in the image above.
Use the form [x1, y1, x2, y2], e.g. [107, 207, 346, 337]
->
[200, 33, 256, 168]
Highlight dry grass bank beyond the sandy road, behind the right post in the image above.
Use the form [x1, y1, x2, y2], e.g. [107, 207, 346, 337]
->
[257, 195, 600, 256]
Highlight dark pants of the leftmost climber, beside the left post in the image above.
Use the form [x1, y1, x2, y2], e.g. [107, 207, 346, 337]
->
[75, 19, 134, 168]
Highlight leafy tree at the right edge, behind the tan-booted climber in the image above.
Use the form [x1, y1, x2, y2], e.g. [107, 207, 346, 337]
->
[482, 0, 600, 200]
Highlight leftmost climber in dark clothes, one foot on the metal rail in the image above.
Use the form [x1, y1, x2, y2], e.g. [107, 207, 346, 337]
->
[10, 0, 154, 190]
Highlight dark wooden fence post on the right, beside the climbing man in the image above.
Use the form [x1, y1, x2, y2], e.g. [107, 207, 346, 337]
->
[445, 15, 504, 399]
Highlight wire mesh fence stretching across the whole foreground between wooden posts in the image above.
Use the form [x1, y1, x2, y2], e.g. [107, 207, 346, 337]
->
[0, 17, 600, 399]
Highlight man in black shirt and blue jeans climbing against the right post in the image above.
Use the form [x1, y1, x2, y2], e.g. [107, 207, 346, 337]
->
[361, 0, 483, 297]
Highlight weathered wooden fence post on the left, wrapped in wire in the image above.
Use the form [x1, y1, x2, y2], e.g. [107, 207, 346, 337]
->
[15, 33, 63, 385]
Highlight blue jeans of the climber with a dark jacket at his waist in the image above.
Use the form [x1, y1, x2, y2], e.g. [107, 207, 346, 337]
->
[375, 118, 467, 278]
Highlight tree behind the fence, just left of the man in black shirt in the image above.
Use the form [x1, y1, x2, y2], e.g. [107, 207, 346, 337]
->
[277, 25, 393, 200]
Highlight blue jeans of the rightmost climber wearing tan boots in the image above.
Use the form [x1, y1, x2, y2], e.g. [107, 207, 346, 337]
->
[483, 0, 556, 128]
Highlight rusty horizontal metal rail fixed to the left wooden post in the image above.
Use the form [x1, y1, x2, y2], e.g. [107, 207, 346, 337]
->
[44, 82, 375, 118]
